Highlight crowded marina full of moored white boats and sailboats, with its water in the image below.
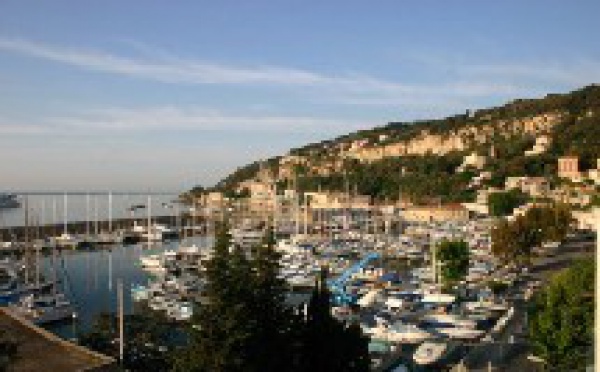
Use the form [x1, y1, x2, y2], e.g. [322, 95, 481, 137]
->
[0, 192, 592, 370]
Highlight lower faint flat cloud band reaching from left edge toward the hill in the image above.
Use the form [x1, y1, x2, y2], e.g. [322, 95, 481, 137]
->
[0, 105, 373, 136]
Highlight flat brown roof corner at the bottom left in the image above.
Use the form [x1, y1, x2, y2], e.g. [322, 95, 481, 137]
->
[0, 308, 116, 372]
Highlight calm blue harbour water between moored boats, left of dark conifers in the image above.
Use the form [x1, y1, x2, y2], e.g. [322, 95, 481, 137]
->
[44, 237, 209, 338]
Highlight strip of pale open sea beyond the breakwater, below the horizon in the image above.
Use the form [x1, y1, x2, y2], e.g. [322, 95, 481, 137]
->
[0, 194, 179, 227]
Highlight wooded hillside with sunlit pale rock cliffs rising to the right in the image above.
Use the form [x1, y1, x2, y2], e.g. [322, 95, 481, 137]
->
[207, 85, 600, 202]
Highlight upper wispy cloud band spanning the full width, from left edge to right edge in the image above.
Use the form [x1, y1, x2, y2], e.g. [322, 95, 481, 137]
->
[0, 37, 600, 108]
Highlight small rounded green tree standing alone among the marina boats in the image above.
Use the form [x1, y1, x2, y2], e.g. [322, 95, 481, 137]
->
[435, 240, 469, 285]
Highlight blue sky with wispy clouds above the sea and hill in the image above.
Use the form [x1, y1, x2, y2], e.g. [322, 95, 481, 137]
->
[0, 0, 600, 191]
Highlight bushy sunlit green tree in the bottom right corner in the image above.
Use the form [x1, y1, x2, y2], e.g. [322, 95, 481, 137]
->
[529, 260, 595, 371]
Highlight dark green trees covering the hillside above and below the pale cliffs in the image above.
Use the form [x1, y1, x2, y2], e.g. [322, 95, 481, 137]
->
[199, 85, 600, 203]
